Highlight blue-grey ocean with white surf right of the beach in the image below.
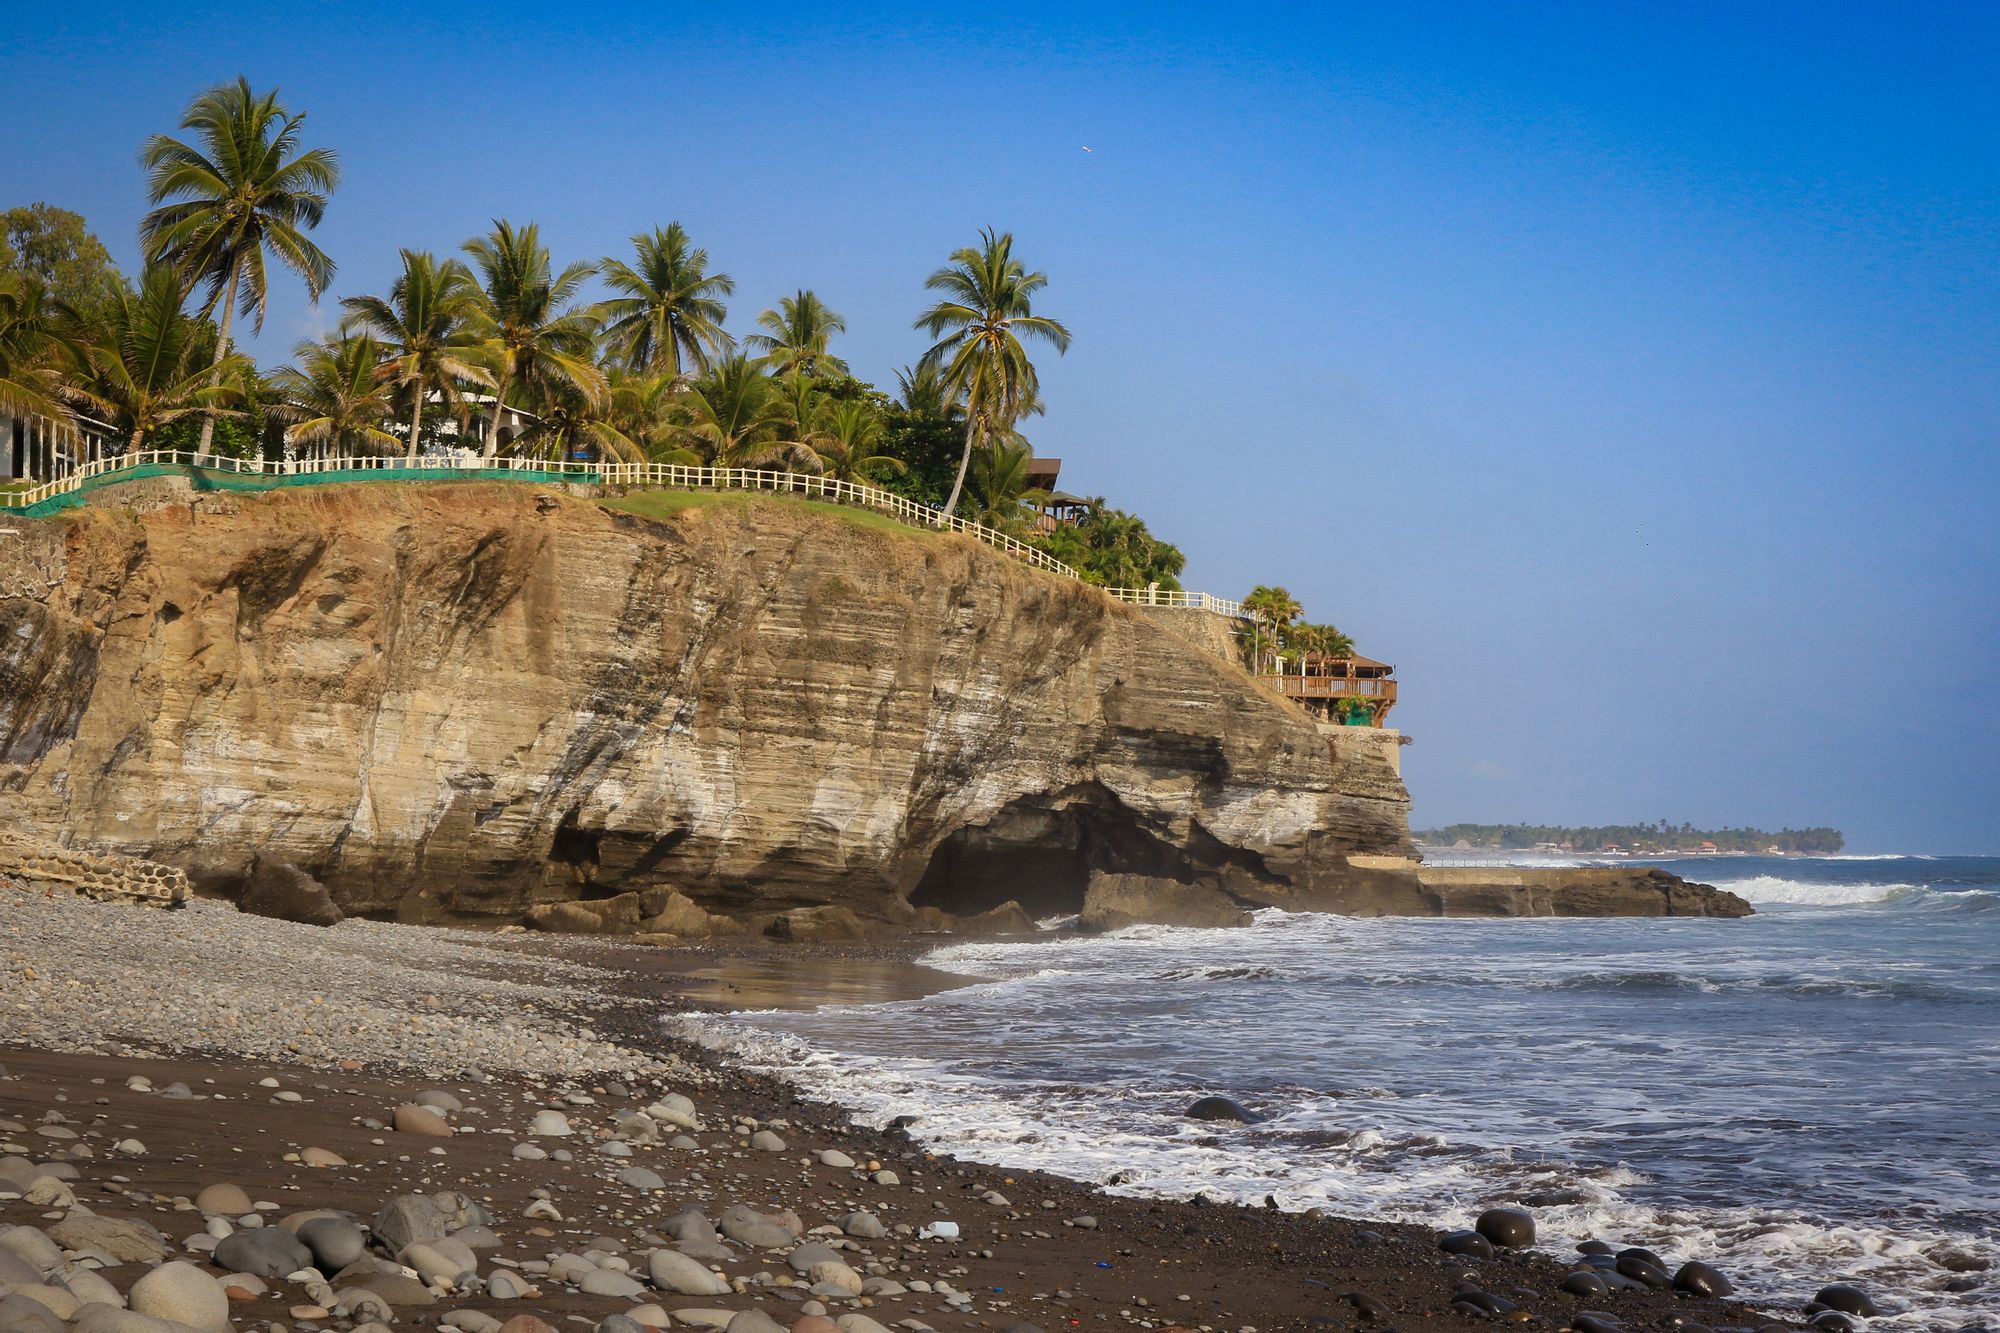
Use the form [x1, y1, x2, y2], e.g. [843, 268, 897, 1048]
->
[686, 857, 2000, 1329]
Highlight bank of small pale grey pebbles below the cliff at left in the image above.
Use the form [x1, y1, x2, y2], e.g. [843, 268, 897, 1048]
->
[0, 891, 684, 1077]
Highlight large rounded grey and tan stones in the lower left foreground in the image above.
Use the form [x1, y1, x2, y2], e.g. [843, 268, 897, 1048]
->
[0, 1071, 1040, 1333]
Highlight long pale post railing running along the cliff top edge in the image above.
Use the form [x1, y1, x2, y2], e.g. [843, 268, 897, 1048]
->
[0, 450, 1246, 618]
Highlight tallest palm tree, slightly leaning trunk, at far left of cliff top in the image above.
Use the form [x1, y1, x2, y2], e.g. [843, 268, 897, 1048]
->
[140, 78, 340, 458]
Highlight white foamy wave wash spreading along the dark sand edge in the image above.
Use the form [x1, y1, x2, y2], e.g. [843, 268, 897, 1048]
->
[670, 1015, 2000, 1327]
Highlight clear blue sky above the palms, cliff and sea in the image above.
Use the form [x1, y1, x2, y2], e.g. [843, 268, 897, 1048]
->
[11, 0, 2000, 853]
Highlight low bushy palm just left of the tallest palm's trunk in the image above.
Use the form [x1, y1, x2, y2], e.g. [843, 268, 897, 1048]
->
[68, 264, 254, 452]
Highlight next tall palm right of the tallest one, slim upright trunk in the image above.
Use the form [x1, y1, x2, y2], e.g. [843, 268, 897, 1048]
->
[340, 250, 494, 458]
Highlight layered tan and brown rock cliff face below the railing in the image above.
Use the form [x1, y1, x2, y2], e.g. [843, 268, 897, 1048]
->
[0, 484, 1410, 921]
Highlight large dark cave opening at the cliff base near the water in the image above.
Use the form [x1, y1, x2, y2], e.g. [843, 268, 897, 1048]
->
[910, 791, 1190, 919]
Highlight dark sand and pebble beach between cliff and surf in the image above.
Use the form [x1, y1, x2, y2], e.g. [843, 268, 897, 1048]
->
[0, 889, 1808, 1333]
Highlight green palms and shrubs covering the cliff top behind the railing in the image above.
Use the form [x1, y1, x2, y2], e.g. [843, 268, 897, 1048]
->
[0, 78, 1184, 588]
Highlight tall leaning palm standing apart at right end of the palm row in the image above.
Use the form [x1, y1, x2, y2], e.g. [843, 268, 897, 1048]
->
[916, 228, 1070, 514]
